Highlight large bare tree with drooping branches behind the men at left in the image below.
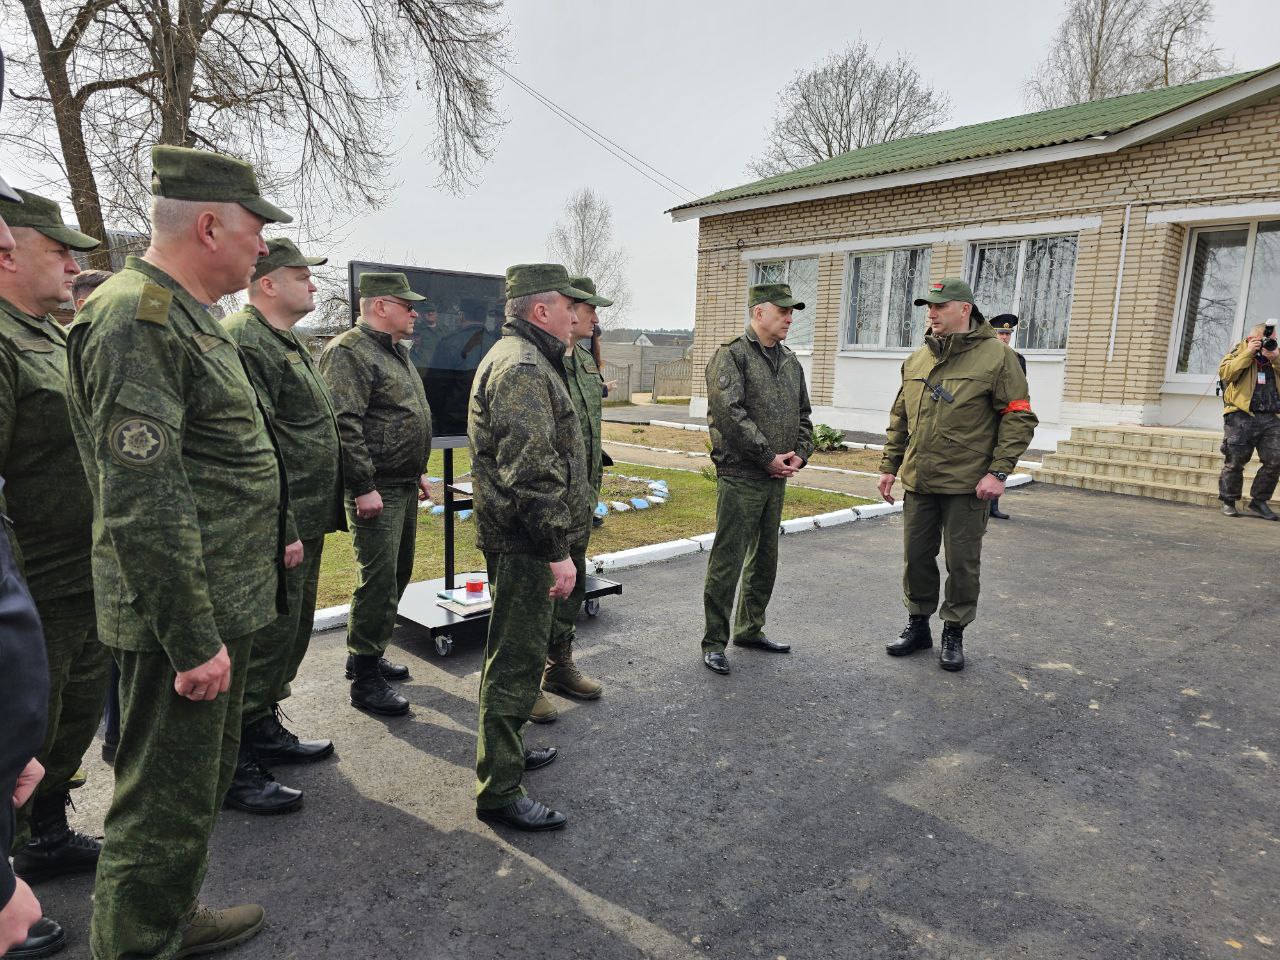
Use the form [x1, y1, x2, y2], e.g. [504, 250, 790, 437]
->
[0, 0, 507, 271]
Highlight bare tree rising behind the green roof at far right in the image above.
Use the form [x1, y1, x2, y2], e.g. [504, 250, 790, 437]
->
[1024, 0, 1230, 110]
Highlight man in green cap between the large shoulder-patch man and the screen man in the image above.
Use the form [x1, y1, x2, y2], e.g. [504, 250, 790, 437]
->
[223, 237, 347, 813]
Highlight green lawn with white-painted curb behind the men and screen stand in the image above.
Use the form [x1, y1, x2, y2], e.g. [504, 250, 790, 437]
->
[317, 458, 868, 607]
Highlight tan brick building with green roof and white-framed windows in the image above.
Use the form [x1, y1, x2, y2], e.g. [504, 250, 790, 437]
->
[671, 64, 1280, 447]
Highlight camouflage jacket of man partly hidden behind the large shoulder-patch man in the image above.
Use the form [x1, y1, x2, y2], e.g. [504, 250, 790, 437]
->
[223, 312, 347, 543]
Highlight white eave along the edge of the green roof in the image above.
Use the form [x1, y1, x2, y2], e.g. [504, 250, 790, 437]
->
[667, 64, 1280, 223]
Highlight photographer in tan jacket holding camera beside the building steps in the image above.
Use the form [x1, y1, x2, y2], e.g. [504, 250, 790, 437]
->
[1217, 320, 1280, 520]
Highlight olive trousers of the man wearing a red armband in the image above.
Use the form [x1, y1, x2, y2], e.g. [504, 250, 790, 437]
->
[902, 490, 991, 626]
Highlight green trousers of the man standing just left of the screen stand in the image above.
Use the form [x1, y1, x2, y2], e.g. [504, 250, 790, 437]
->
[347, 484, 417, 657]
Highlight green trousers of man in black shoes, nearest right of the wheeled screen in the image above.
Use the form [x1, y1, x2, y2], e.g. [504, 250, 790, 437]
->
[476, 552, 554, 809]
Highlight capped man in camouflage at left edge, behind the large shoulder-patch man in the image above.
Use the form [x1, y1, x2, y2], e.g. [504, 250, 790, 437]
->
[0, 191, 110, 901]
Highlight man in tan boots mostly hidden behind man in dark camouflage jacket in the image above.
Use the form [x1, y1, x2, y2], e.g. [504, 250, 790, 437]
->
[529, 276, 613, 723]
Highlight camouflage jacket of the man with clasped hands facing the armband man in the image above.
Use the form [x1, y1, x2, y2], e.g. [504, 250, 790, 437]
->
[707, 326, 813, 480]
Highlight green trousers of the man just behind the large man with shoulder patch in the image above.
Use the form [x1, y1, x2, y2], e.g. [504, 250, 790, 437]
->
[241, 536, 324, 727]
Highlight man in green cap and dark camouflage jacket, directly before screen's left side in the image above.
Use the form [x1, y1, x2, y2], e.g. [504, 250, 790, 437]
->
[320, 273, 431, 717]
